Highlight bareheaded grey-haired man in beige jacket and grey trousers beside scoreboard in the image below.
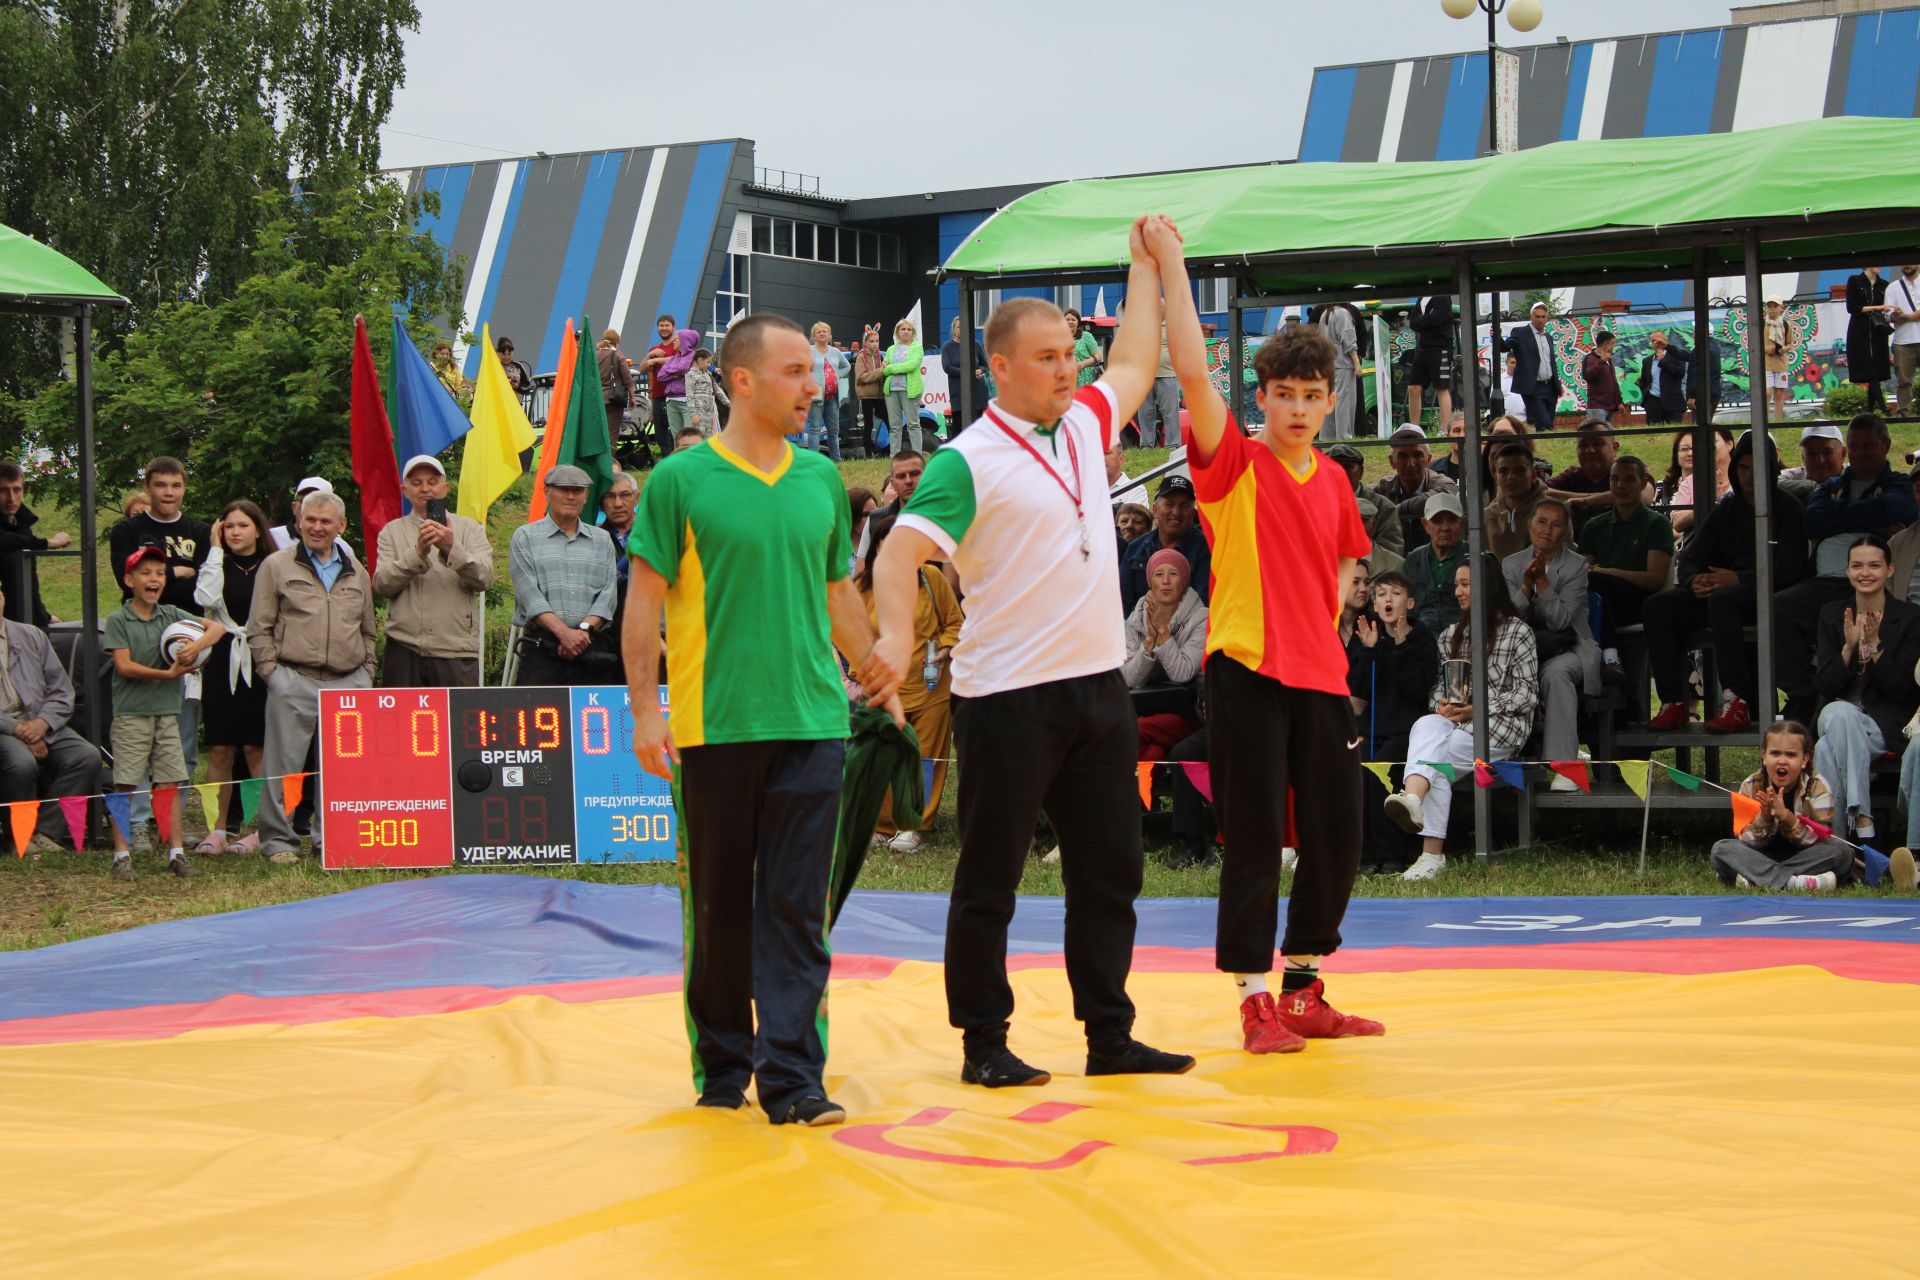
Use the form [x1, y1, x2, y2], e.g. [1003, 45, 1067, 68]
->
[246, 493, 372, 864]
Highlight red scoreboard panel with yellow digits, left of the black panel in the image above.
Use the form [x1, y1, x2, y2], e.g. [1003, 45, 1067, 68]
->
[319, 689, 453, 867]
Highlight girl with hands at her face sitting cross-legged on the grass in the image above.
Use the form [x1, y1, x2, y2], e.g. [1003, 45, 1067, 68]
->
[1713, 720, 1853, 892]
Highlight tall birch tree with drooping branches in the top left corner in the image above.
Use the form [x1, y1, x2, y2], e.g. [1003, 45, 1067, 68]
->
[0, 0, 420, 404]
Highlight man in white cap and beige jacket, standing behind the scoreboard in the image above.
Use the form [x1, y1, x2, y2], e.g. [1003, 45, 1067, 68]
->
[372, 453, 493, 689]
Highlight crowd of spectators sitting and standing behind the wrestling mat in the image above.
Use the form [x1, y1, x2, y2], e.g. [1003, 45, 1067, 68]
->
[11, 289, 1920, 901]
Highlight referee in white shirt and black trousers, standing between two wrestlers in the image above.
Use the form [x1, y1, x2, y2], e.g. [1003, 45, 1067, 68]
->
[874, 225, 1194, 1088]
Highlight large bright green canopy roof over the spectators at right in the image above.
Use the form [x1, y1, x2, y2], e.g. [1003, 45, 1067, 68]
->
[945, 117, 1920, 294]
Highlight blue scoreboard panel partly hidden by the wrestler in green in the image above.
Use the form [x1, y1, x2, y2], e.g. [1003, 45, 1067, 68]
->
[572, 685, 678, 862]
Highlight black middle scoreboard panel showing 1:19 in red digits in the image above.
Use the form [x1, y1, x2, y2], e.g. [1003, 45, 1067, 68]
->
[449, 689, 576, 865]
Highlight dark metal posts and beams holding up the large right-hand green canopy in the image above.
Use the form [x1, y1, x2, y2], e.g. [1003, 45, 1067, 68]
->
[933, 205, 1920, 860]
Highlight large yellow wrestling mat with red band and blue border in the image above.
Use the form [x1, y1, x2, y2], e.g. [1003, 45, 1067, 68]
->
[0, 875, 1920, 1280]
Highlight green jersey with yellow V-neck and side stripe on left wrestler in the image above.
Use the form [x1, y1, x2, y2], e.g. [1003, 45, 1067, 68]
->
[628, 438, 852, 747]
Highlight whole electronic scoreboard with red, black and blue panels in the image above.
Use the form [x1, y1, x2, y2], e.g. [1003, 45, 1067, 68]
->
[319, 685, 678, 869]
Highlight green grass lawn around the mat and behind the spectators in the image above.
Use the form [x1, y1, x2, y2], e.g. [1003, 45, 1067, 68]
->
[15, 426, 1920, 950]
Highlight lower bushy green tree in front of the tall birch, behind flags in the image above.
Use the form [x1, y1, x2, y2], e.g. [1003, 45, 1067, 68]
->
[25, 161, 463, 541]
